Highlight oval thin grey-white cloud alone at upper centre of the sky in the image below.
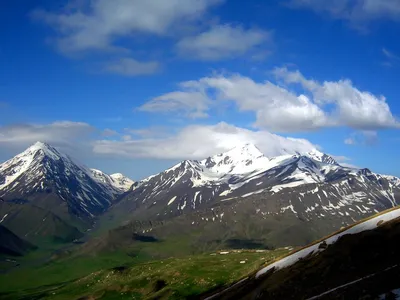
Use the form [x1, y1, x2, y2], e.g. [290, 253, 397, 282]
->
[177, 24, 272, 60]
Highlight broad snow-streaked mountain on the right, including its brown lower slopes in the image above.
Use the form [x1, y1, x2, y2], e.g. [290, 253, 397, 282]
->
[97, 144, 400, 250]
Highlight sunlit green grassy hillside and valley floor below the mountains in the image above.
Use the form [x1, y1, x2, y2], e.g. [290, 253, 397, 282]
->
[0, 249, 289, 300]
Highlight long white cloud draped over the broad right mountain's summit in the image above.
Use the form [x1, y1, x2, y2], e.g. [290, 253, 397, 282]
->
[93, 122, 317, 160]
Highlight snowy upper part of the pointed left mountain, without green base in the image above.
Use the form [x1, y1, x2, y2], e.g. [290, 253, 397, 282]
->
[0, 142, 134, 216]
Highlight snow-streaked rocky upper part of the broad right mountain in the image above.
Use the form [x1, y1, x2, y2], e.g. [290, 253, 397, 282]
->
[110, 144, 400, 219]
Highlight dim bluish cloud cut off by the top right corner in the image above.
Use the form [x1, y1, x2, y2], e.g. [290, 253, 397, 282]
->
[288, 0, 400, 25]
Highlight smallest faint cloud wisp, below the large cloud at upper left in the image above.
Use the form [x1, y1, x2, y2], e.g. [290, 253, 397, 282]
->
[103, 58, 160, 76]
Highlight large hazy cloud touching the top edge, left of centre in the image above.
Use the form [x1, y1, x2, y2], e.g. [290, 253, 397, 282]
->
[32, 0, 222, 53]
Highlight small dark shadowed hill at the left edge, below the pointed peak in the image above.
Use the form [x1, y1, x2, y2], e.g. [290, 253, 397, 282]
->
[0, 225, 36, 256]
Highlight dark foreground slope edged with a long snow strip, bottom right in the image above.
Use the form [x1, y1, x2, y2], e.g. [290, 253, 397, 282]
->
[203, 208, 400, 300]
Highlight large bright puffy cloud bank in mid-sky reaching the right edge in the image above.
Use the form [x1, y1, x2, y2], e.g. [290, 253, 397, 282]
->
[140, 68, 400, 132]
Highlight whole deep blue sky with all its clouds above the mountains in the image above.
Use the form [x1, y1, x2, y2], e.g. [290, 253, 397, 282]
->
[0, 0, 400, 179]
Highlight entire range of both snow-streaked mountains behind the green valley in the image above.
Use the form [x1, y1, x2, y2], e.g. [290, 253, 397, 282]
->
[0, 142, 400, 251]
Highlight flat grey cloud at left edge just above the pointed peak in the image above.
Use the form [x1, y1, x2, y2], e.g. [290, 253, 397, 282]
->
[0, 121, 95, 149]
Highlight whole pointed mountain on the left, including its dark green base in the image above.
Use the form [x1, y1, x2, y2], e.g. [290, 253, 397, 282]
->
[0, 142, 133, 244]
